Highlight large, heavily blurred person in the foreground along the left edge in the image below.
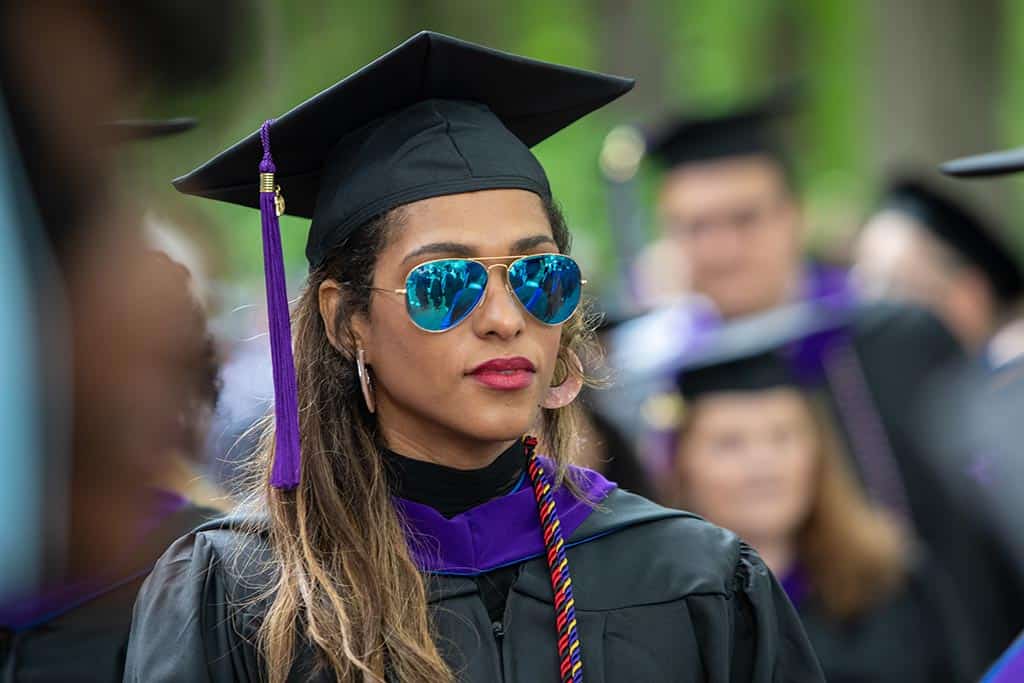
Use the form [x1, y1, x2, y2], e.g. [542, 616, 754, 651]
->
[0, 2, 245, 681]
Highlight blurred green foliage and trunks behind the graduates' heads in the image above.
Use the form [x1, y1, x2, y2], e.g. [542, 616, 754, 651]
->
[126, 0, 1024, 301]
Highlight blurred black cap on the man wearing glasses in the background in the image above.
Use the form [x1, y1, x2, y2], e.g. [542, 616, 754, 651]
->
[647, 83, 801, 167]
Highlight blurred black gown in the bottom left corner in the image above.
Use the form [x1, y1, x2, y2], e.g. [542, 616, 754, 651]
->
[0, 505, 216, 683]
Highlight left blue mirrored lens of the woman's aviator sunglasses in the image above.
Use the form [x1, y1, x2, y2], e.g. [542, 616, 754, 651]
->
[406, 259, 487, 332]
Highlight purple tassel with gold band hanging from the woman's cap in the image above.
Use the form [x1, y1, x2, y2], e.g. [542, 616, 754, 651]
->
[259, 119, 302, 489]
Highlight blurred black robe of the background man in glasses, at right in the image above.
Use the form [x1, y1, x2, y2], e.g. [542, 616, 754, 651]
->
[829, 303, 1024, 675]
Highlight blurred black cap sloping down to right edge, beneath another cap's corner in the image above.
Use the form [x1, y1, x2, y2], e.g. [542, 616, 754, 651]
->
[883, 178, 1024, 302]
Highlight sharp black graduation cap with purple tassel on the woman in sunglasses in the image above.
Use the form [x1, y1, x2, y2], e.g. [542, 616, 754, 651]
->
[174, 31, 633, 488]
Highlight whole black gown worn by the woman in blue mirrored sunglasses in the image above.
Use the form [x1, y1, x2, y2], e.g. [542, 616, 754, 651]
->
[125, 488, 823, 683]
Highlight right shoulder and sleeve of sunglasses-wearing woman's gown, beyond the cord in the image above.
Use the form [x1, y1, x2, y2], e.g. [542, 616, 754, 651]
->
[552, 489, 824, 682]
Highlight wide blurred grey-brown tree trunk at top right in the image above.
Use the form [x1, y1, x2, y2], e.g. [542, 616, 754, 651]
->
[867, 0, 1013, 219]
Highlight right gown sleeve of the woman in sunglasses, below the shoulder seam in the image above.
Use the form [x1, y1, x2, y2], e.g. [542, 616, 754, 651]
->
[688, 543, 825, 683]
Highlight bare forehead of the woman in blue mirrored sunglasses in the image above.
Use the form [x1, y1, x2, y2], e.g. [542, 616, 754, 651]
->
[388, 189, 552, 257]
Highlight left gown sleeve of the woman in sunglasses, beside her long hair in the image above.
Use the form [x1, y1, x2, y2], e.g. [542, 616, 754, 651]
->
[124, 532, 259, 683]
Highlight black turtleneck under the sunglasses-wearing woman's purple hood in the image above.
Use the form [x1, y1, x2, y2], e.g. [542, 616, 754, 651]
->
[384, 439, 529, 626]
